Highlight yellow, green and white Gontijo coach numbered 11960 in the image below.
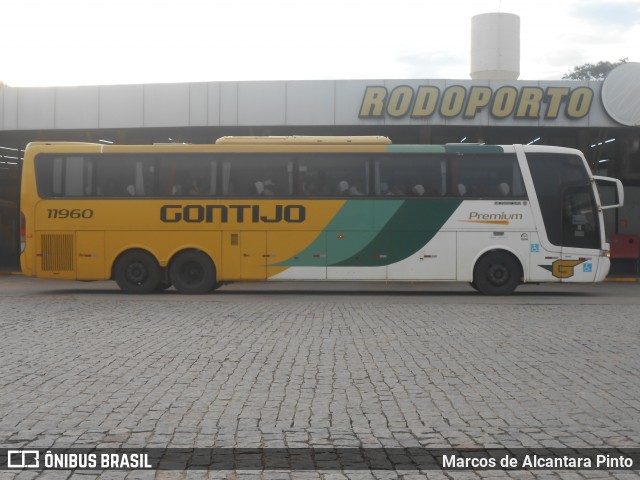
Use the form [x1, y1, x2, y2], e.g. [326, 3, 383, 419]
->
[20, 136, 623, 295]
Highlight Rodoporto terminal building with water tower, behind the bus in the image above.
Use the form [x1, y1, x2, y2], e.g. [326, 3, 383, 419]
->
[0, 13, 640, 270]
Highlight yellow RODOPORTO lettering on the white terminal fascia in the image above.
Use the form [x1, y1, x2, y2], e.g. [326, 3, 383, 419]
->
[359, 85, 594, 120]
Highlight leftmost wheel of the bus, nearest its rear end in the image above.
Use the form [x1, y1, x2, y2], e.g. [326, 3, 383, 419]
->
[113, 250, 162, 294]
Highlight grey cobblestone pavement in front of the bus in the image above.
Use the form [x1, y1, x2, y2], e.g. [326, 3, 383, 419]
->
[0, 277, 640, 480]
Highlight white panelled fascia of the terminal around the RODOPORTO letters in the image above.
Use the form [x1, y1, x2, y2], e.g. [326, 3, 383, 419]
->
[0, 76, 640, 131]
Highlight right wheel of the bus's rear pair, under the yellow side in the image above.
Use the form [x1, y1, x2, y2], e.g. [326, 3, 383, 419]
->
[169, 250, 218, 295]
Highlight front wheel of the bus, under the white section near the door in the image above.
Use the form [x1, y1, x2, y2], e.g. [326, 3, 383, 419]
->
[473, 252, 522, 295]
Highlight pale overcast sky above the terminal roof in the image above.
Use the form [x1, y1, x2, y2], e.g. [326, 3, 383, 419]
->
[0, 0, 640, 87]
